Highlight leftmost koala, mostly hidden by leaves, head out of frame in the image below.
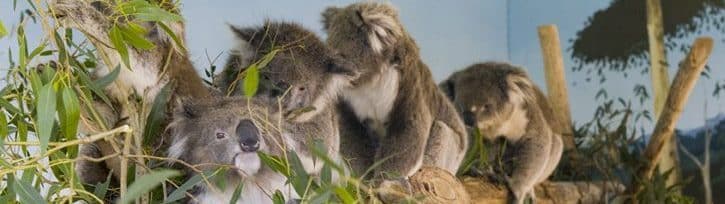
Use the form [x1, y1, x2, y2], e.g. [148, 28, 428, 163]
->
[49, 0, 211, 184]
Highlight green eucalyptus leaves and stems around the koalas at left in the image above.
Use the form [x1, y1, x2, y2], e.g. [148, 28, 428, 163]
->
[0, 0, 371, 203]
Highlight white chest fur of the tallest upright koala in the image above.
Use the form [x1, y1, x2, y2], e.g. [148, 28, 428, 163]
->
[342, 66, 400, 136]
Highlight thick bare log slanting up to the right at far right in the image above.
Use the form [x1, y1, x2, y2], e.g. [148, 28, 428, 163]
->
[632, 37, 713, 193]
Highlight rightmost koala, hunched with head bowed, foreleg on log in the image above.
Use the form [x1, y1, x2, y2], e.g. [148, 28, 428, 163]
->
[440, 62, 563, 203]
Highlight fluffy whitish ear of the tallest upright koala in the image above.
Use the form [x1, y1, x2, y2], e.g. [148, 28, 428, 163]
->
[356, 3, 403, 53]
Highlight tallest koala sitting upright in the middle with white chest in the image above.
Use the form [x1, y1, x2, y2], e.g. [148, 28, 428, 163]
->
[322, 2, 468, 179]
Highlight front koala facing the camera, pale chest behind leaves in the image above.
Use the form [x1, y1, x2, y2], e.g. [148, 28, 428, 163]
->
[168, 98, 292, 203]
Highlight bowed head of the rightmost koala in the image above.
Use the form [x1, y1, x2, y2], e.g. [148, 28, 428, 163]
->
[440, 63, 533, 137]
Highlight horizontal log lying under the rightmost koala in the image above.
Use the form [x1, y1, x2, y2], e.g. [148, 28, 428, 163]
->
[462, 177, 625, 204]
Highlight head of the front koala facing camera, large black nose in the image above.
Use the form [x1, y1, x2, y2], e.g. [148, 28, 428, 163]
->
[168, 98, 283, 177]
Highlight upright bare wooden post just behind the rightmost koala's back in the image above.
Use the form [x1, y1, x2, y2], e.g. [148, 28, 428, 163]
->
[538, 25, 575, 150]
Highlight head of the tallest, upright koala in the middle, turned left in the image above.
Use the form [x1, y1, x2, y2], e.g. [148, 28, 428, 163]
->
[322, 2, 418, 81]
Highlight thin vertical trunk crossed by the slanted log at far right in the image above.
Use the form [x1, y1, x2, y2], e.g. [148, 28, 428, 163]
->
[646, 0, 680, 190]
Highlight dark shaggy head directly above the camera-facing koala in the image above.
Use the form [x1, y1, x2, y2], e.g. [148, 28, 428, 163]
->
[223, 22, 358, 122]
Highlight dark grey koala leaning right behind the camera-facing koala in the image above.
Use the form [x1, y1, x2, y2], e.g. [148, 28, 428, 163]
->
[215, 21, 359, 175]
